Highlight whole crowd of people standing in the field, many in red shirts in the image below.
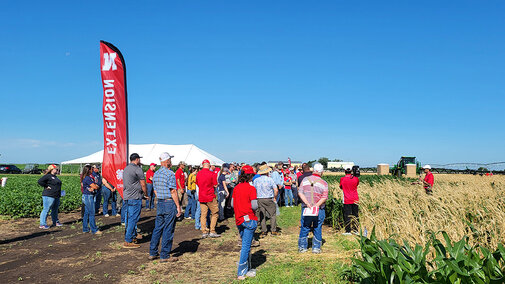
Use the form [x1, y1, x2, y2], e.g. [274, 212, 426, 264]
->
[39, 152, 433, 279]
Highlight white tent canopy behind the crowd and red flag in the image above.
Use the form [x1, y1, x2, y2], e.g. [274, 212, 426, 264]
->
[61, 144, 224, 166]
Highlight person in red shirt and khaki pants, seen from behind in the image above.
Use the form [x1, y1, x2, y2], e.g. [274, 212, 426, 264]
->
[196, 160, 221, 238]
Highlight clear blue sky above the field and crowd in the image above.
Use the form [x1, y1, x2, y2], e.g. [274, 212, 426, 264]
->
[0, 1, 505, 165]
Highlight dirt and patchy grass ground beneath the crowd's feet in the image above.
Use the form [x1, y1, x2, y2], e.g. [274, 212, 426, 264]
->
[0, 207, 356, 283]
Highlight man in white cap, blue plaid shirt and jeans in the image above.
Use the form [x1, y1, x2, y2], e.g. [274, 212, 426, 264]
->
[149, 152, 182, 262]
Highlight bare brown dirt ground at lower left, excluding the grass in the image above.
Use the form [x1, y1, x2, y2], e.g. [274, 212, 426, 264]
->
[0, 211, 205, 283]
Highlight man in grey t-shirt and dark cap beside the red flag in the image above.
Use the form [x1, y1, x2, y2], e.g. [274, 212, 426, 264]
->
[121, 153, 147, 248]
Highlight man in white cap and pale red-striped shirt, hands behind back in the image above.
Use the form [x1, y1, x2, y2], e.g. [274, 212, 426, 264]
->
[298, 163, 328, 253]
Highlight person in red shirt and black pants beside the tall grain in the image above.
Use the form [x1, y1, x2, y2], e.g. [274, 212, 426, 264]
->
[340, 168, 359, 235]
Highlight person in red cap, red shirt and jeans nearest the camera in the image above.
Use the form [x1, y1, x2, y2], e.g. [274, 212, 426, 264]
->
[232, 165, 258, 280]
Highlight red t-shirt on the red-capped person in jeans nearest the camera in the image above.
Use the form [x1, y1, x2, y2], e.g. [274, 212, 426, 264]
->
[233, 182, 258, 226]
